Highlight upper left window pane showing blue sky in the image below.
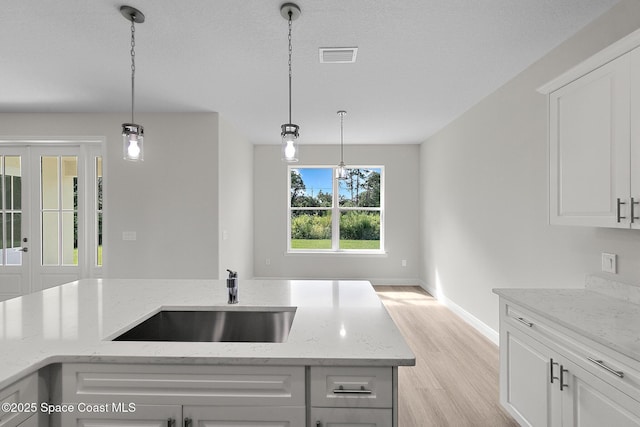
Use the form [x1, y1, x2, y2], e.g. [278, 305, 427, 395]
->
[289, 168, 333, 207]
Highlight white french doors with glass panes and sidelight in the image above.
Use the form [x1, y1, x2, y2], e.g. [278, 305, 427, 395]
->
[0, 143, 102, 300]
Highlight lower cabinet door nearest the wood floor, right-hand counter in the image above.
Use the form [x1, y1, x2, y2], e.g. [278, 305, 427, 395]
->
[500, 322, 561, 426]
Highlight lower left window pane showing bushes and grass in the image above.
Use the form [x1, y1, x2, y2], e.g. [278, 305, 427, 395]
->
[291, 210, 331, 249]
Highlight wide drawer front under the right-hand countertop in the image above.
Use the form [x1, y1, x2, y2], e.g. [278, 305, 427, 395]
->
[503, 303, 640, 400]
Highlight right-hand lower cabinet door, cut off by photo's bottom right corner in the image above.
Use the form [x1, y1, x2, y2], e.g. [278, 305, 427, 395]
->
[562, 360, 640, 427]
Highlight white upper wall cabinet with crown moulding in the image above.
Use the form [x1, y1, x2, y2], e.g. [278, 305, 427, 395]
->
[538, 31, 640, 229]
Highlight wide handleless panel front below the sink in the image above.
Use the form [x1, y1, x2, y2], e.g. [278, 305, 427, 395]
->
[62, 364, 305, 406]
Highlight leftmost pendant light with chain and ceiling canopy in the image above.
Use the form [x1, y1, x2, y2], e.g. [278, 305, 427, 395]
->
[120, 6, 144, 162]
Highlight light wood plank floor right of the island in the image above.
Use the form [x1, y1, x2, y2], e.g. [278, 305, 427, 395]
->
[375, 286, 518, 427]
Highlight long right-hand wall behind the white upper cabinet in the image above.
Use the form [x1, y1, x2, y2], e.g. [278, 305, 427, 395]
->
[420, 0, 640, 340]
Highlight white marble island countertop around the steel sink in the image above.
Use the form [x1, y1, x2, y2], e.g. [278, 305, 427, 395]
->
[0, 279, 415, 389]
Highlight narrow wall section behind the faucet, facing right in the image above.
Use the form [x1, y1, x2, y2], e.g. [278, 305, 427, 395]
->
[218, 118, 253, 279]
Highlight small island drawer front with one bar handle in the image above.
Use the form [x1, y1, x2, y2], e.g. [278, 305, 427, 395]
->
[311, 367, 393, 408]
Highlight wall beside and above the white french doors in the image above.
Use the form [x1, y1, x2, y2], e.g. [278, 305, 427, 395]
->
[0, 113, 218, 278]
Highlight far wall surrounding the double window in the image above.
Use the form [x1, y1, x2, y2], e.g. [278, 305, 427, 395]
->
[254, 144, 421, 285]
